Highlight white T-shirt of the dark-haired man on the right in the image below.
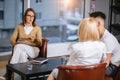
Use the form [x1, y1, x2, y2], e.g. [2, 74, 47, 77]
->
[101, 30, 120, 66]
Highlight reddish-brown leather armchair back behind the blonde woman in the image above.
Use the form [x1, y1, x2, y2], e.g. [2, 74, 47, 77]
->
[57, 63, 106, 80]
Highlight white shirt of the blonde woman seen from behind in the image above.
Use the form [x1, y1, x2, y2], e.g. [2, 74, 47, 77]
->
[67, 41, 106, 65]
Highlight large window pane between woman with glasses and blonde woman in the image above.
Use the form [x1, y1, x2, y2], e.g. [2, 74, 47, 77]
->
[30, 0, 84, 43]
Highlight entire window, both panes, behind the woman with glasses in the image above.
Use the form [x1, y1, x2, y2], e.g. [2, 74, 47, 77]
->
[0, 0, 84, 52]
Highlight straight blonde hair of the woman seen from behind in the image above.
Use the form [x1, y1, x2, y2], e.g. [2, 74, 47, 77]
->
[78, 18, 99, 42]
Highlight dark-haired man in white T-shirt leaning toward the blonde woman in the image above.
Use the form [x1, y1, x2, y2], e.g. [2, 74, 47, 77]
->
[90, 11, 120, 78]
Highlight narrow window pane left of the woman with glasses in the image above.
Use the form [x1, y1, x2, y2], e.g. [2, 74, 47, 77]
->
[0, 0, 23, 53]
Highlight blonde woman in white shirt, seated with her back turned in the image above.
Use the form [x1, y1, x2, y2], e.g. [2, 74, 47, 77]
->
[47, 18, 106, 80]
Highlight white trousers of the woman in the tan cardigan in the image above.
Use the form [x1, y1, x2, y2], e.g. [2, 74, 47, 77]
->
[10, 44, 39, 64]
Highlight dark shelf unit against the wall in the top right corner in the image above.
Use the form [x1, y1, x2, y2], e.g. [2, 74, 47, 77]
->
[109, 0, 120, 33]
